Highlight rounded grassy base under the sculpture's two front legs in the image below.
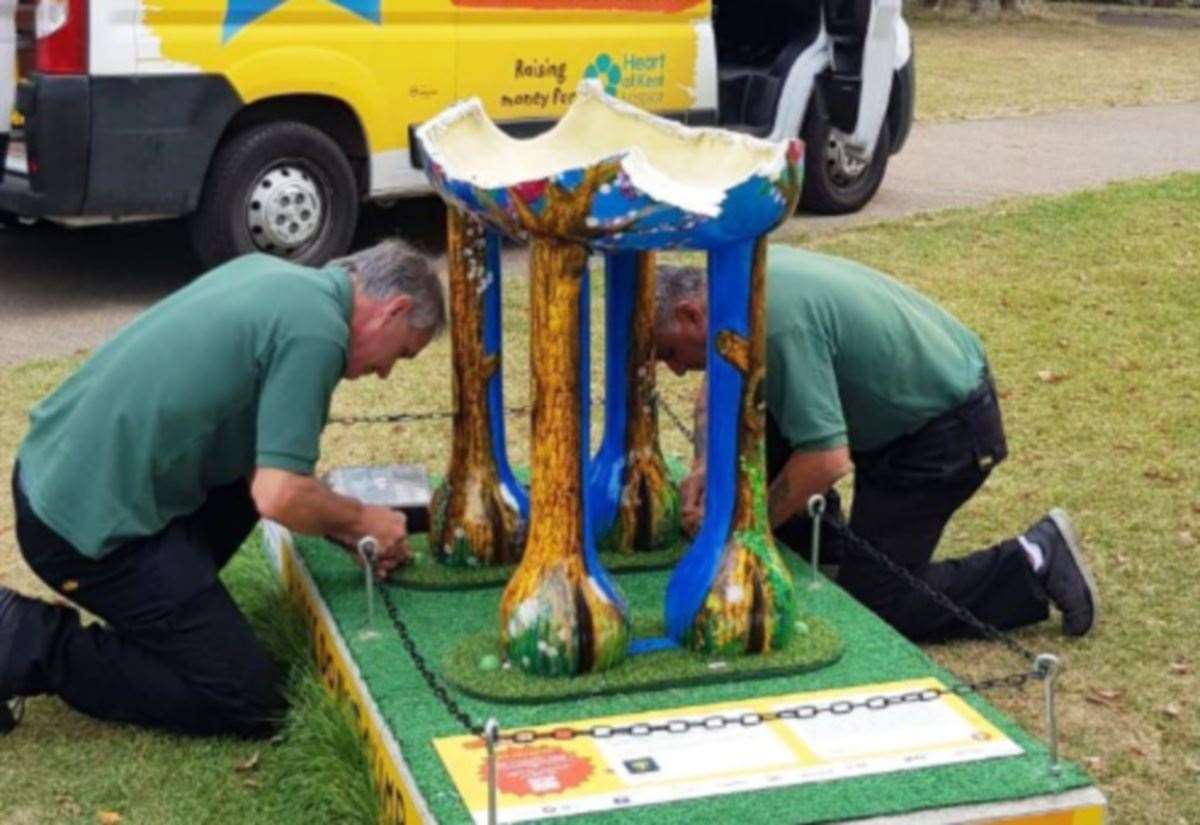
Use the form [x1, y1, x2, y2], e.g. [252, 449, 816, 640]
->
[440, 611, 841, 704]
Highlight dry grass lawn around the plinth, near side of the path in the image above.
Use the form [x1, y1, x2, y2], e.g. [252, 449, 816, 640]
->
[0, 175, 1200, 825]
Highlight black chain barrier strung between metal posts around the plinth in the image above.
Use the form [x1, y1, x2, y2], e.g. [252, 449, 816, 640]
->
[355, 398, 1054, 745]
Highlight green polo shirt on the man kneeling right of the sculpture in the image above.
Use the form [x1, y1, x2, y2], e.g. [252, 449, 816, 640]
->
[767, 246, 986, 452]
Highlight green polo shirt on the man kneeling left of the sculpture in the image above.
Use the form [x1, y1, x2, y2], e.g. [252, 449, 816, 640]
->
[18, 254, 353, 559]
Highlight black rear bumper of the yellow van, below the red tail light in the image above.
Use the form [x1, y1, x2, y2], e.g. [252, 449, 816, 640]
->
[0, 74, 241, 218]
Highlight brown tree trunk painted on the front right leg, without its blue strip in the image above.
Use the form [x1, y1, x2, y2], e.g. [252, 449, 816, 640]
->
[689, 239, 796, 655]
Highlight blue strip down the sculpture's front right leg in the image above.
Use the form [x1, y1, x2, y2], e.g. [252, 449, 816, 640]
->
[665, 241, 755, 642]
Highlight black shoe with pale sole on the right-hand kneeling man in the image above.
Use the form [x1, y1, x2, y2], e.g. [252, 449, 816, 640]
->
[1025, 507, 1100, 636]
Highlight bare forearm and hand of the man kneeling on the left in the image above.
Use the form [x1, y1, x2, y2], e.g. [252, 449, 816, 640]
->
[250, 466, 409, 574]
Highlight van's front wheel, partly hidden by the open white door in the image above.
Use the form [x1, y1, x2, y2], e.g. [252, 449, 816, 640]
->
[800, 107, 892, 215]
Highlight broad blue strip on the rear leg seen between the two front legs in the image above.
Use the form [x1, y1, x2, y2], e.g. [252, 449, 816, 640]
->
[588, 252, 637, 540]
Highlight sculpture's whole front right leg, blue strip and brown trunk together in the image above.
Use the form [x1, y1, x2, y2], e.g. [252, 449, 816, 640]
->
[667, 239, 796, 655]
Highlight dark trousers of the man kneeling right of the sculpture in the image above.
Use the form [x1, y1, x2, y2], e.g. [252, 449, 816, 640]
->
[768, 379, 1049, 640]
